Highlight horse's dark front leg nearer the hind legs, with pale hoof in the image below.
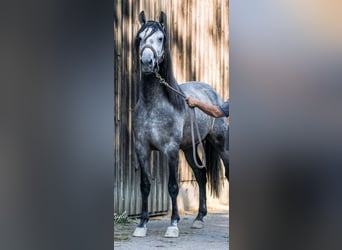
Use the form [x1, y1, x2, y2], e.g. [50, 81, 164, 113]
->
[165, 149, 180, 237]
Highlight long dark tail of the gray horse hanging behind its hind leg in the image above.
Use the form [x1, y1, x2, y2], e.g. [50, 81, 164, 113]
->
[204, 140, 223, 197]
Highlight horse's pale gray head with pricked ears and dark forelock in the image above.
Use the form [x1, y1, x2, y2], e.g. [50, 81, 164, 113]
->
[135, 11, 166, 74]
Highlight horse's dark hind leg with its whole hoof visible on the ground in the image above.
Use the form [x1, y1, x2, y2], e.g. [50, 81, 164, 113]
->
[184, 148, 207, 228]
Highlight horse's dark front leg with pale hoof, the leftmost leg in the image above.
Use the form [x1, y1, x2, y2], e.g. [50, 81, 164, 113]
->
[133, 143, 151, 237]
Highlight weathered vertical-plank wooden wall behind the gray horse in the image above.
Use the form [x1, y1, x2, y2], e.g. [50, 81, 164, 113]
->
[114, 0, 229, 215]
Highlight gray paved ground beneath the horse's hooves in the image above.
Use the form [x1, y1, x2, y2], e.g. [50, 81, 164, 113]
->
[114, 210, 229, 250]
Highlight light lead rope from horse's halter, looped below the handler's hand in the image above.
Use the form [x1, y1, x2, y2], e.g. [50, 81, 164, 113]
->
[155, 72, 206, 168]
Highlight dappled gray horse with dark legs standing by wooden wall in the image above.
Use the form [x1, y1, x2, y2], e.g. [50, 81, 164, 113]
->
[133, 11, 229, 237]
